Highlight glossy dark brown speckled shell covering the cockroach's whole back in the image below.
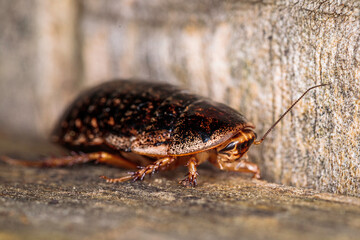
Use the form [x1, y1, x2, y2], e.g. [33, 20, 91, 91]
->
[53, 80, 254, 156]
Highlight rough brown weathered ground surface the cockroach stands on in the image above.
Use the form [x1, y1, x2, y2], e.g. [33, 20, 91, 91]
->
[0, 134, 360, 240]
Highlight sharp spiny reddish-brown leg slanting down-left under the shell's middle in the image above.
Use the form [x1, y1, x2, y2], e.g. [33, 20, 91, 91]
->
[101, 157, 175, 183]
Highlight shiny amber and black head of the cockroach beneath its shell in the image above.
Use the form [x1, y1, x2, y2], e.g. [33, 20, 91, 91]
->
[216, 129, 256, 163]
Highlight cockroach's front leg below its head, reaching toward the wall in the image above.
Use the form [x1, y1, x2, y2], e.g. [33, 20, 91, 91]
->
[211, 160, 260, 179]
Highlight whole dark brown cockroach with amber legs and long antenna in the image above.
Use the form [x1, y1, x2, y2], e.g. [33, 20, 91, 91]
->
[2, 80, 328, 186]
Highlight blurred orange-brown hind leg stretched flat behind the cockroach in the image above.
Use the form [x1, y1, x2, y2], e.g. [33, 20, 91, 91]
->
[0, 152, 137, 169]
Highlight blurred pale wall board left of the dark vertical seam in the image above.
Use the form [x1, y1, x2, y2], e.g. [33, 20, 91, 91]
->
[0, 0, 81, 136]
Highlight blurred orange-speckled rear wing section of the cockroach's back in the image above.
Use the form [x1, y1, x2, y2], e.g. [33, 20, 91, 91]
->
[53, 80, 180, 151]
